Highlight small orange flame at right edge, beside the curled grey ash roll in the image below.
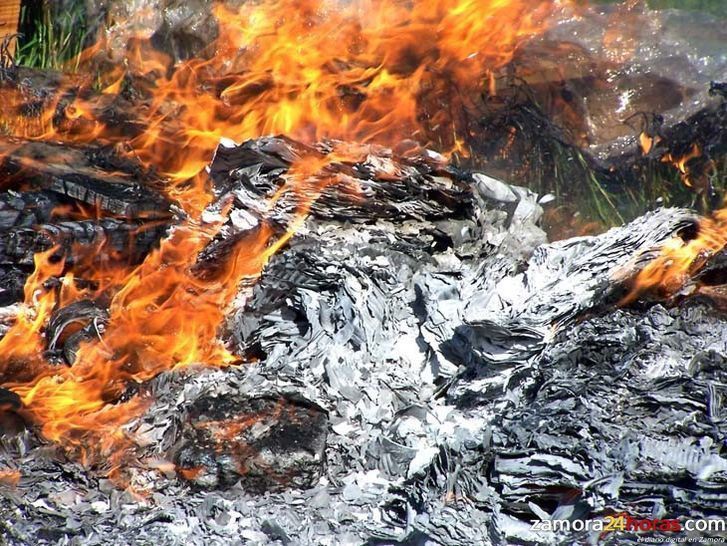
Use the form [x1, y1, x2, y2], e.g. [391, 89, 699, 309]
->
[621, 208, 727, 305]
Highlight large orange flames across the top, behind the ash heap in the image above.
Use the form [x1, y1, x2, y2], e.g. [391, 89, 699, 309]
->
[0, 0, 555, 204]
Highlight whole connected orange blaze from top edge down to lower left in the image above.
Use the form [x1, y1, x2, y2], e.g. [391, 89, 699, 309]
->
[0, 0, 554, 468]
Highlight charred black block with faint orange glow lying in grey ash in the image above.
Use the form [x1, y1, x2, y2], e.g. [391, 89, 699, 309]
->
[176, 394, 328, 492]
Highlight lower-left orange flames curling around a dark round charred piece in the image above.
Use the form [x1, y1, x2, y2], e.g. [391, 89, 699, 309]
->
[0, 180, 314, 454]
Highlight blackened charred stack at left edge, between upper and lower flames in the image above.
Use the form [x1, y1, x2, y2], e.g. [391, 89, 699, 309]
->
[0, 139, 178, 305]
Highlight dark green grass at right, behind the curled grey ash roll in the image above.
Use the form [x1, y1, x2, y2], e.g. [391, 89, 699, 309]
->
[461, 103, 727, 235]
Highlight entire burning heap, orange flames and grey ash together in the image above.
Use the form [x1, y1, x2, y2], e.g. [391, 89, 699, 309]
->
[0, 0, 727, 544]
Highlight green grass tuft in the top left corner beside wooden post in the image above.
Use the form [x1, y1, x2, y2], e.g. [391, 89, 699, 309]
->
[15, 0, 88, 72]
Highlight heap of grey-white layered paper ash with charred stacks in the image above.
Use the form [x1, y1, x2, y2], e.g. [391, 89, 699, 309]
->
[0, 137, 727, 545]
